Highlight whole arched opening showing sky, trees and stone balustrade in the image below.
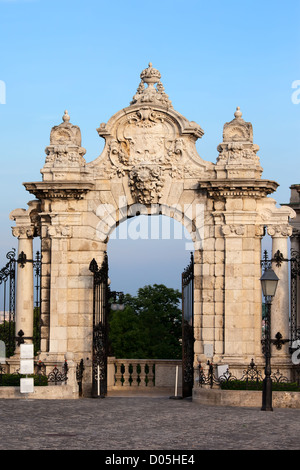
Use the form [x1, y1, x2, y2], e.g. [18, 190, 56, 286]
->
[107, 213, 194, 394]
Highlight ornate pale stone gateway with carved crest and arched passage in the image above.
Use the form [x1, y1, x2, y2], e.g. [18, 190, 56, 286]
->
[10, 63, 295, 393]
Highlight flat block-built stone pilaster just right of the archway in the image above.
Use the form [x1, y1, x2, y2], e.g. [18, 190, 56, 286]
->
[222, 217, 261, 366]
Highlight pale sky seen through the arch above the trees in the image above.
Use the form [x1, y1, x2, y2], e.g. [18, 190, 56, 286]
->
[107, 215, 194, 295]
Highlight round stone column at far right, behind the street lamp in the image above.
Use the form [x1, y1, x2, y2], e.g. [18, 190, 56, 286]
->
[268, 225, 292, 358]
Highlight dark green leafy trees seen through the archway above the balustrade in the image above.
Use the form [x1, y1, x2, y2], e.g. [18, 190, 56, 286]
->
[109, 284, 182, 359]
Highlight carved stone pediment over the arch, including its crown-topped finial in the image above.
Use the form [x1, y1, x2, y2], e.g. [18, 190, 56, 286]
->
[92, 63, 213, 203]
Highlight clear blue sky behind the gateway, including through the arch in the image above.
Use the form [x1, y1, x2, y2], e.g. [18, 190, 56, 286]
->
[0, 0, 300, 291]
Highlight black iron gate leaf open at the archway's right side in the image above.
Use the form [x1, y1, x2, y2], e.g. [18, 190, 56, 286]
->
[181, 253, 195, 398]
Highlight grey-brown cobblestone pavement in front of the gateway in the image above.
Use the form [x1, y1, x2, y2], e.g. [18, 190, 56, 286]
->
[0, 397, 300, 451]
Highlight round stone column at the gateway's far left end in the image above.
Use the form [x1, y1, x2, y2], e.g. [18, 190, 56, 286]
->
[13, 225, 34, 343]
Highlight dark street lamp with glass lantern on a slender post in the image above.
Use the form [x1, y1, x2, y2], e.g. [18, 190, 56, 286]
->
[260, 269, 279, 411]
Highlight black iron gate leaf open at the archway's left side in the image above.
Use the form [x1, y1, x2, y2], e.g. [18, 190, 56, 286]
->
[89, 253, 109, 397]
